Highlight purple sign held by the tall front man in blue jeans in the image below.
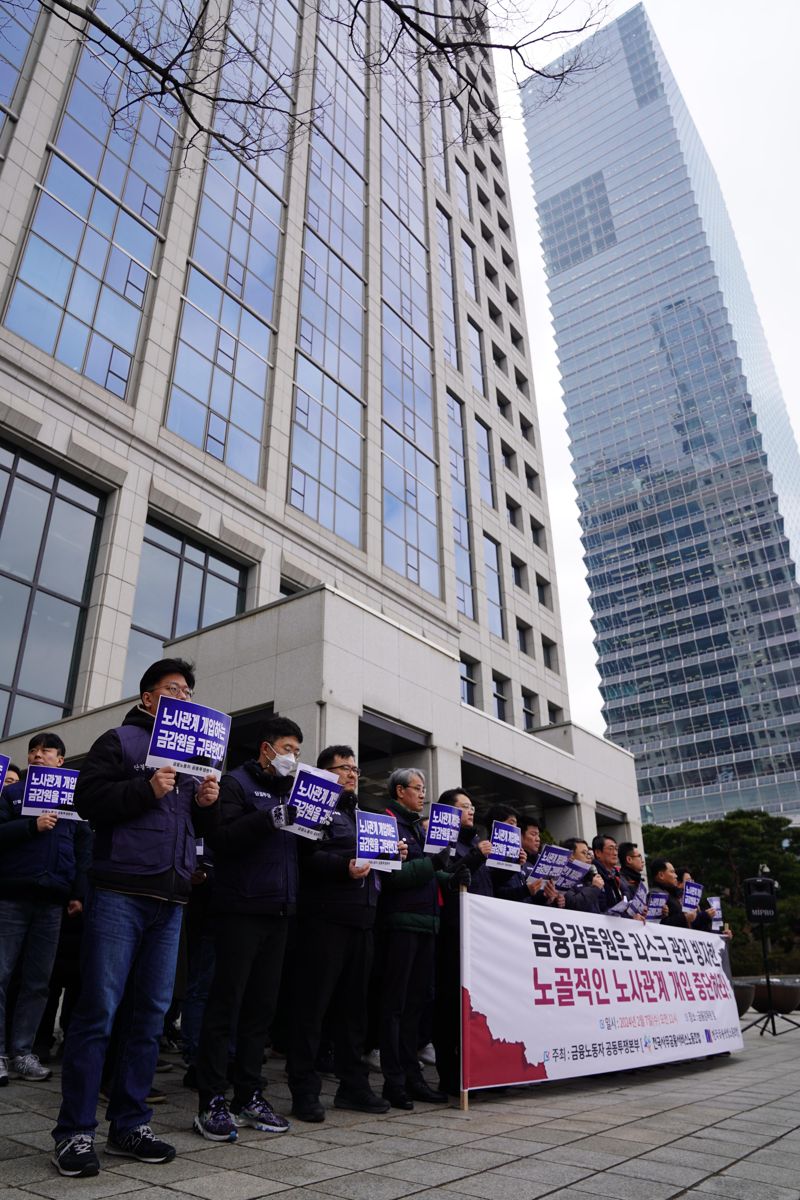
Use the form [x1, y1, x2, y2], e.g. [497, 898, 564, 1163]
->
[145, 696, 230, 779]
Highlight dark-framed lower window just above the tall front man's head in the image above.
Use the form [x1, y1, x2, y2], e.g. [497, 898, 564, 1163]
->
[122, 521, 247, 696]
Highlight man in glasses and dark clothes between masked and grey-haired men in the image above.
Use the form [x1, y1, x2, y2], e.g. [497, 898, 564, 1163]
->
[288, 745, 390, 1122]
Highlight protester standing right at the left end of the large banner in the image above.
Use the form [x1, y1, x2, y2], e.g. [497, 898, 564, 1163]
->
[433, 787, 493, 1096]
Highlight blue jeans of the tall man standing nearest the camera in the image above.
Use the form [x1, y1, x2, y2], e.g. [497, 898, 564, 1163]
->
[53, 888, 181, 1142]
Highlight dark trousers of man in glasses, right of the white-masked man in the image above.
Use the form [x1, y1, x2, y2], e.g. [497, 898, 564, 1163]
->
[288, 918, 372, 1100]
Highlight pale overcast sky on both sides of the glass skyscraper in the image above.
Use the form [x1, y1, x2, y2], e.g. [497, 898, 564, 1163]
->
[495, 0, 800, 733]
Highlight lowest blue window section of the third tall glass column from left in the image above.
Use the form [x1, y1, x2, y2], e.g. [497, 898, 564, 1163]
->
[289, 354, 363, 546]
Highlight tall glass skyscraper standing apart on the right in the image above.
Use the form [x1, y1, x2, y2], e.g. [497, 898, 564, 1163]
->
[523, 5, 800, 822]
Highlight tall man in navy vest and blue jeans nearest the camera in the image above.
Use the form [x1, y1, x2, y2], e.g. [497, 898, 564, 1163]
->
[53, 659, 219, 1176]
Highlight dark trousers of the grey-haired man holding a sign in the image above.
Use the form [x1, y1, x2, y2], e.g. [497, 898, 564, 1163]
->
[380, 929, 437, 1088]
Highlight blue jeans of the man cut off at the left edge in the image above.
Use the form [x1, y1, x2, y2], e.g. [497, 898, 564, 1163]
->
[0, 900, 62, 1057]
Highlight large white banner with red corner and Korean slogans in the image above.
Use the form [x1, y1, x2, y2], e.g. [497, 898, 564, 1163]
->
[461, 893, 742, 1091]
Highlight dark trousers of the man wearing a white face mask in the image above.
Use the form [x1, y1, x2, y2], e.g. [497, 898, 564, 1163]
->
[197, 913, 288, 1111]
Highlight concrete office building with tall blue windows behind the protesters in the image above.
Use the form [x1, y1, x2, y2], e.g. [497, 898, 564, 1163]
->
[0, 0, 638, 836]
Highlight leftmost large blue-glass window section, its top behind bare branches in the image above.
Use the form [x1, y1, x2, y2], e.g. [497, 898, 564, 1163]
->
[5, 30, 175, 397]
